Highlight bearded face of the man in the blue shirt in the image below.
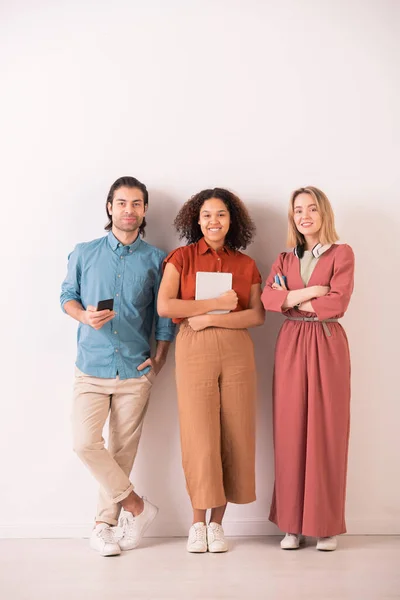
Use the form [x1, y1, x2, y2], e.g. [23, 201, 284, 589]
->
[108, 186, 146, 233]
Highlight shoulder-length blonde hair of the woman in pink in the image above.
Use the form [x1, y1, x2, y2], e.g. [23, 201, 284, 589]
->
[287, 185, 339, 248]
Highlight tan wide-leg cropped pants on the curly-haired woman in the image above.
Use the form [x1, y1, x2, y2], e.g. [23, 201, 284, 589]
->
[175, 322, 256, 509]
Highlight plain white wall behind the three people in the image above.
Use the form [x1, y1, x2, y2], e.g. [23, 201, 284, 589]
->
[0, 0, 400, 536]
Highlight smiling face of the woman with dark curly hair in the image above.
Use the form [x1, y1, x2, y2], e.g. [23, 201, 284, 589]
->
[198, 198, 231, 249]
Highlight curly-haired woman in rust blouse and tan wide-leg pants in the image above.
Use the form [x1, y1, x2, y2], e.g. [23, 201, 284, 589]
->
[158, 188, 264, 552]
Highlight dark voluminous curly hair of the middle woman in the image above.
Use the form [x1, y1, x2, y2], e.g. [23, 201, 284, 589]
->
[174, 188, 256, 250]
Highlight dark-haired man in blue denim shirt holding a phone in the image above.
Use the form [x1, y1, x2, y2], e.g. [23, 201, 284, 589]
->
[61, 177, 174, 556]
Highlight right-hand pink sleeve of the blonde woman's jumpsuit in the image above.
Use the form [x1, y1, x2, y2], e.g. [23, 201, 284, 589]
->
[311, 244, 354, 321]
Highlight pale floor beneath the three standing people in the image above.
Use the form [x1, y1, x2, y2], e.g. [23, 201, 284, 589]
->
[0, 536, 400, 600]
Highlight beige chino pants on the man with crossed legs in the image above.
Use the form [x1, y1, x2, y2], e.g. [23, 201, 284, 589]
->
[72, 368, 154, 525]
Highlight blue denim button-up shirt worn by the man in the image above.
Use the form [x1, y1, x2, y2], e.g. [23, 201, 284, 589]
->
[60, 232, 175, 379]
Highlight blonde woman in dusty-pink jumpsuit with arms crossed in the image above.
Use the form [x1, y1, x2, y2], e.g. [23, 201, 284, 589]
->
[262, 186, 354, 550]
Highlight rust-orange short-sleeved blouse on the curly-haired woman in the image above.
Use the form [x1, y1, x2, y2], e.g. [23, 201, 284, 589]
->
[164, 238, 261, 323]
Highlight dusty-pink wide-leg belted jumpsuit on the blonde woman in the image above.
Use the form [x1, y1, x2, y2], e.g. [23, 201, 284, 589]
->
[262, 244, 354, 537]
